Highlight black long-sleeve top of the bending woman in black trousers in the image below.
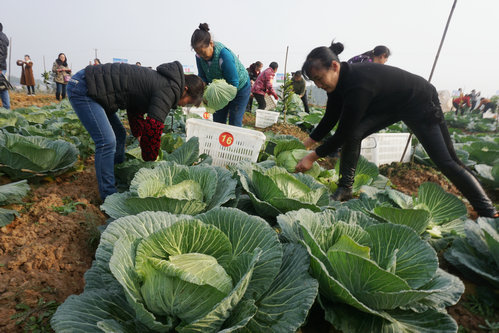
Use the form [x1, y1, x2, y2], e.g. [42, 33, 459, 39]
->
[310, 62, 436, 157]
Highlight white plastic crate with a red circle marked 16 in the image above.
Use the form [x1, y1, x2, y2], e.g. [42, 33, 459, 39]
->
[186, 118, 266, 166]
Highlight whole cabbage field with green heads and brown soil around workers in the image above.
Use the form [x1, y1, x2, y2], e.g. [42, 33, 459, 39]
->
[0, 91, 499, 333]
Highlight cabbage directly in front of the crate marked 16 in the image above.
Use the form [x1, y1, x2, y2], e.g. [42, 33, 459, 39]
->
[101, 161, 237, 218]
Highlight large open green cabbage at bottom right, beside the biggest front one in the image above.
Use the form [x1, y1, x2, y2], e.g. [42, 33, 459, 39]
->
[277, 208, 464, 333]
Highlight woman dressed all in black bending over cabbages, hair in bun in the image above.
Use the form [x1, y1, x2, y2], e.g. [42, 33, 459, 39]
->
[296, 43, 498, 217]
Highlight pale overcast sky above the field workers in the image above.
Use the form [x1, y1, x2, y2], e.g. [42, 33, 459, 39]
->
[0, 0, 499, 96]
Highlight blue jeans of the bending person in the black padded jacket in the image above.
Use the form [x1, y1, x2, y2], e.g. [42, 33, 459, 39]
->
[68, 70, 126, 200]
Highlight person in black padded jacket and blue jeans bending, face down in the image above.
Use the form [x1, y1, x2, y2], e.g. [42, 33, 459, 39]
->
[67, 61, 204, 200]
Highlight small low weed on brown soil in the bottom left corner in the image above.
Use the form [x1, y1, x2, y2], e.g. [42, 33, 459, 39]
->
[11, 297, 59, 333]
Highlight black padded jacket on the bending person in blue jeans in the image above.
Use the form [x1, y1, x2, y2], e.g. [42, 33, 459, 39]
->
[85, 61, 185, 122]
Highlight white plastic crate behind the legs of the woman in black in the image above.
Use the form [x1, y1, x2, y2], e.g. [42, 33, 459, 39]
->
[360, 133, 412, 166]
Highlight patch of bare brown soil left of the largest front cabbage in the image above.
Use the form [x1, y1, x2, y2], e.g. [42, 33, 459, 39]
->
[0, 160, 106, 332]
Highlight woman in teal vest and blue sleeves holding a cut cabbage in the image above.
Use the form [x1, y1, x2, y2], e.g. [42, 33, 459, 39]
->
[191, 23, 251, 127]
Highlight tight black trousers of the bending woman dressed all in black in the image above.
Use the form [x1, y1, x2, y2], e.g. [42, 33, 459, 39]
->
[338, 91, 496, 217]
